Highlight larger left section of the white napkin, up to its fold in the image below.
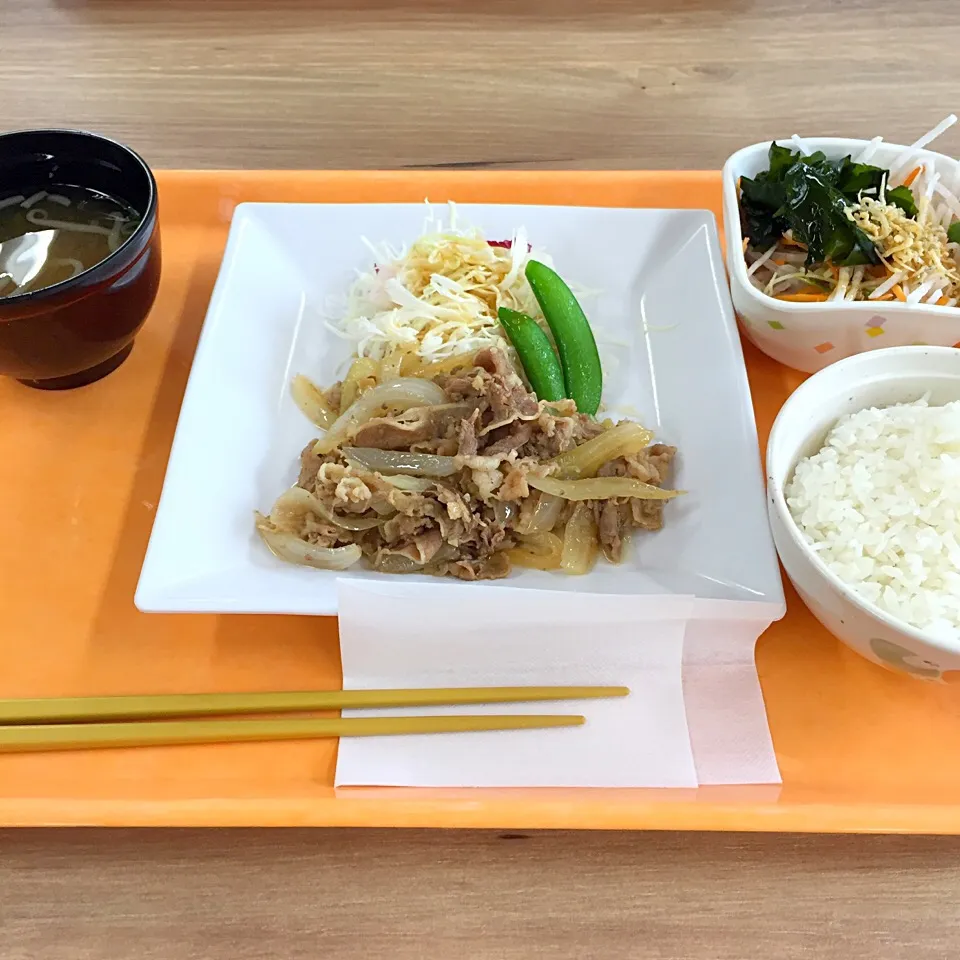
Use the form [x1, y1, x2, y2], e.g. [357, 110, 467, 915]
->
[336, 580, 697, 787]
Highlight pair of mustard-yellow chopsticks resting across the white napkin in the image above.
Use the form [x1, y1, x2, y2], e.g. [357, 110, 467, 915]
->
[0, 687, 629, 753]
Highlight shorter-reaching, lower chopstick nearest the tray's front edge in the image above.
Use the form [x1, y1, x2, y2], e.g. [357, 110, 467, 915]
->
[0, 715, 584, 753]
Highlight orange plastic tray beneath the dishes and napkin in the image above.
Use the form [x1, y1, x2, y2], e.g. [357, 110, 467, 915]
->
[0, 172, 960, 833]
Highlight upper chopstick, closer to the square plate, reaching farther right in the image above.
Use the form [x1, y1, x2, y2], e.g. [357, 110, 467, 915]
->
[0, 687, 630, 724]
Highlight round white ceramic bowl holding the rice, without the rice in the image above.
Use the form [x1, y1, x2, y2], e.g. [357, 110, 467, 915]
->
[767, 347, 960, 679]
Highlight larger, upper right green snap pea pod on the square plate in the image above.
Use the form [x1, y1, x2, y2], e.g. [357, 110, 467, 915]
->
[526, 260, 603, 416]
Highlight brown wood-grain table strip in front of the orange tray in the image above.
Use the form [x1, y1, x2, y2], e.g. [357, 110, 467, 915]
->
[0, 830, 960, 960]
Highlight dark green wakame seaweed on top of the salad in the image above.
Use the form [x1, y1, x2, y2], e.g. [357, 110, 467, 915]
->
[740, 143, 917, 266]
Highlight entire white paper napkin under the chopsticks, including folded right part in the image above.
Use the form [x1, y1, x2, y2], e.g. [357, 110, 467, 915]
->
[336, 580, 779, 787]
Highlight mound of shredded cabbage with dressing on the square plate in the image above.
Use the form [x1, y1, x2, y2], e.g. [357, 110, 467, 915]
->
[330, 203, 552, 362]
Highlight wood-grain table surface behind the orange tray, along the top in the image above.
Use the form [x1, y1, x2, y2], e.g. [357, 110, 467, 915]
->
[0, 0, 960, 169]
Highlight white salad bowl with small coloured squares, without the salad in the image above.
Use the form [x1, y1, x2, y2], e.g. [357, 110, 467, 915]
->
[723, 137, 960, 373]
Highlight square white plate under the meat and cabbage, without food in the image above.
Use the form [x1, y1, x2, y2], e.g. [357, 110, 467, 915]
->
[136, 204, 784, 629]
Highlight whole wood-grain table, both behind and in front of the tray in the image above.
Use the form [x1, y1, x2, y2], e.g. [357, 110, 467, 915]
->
[0, 0, 960, 960]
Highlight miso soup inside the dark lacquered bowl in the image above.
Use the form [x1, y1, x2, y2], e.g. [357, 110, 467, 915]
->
[0, 185, 141, 297]
